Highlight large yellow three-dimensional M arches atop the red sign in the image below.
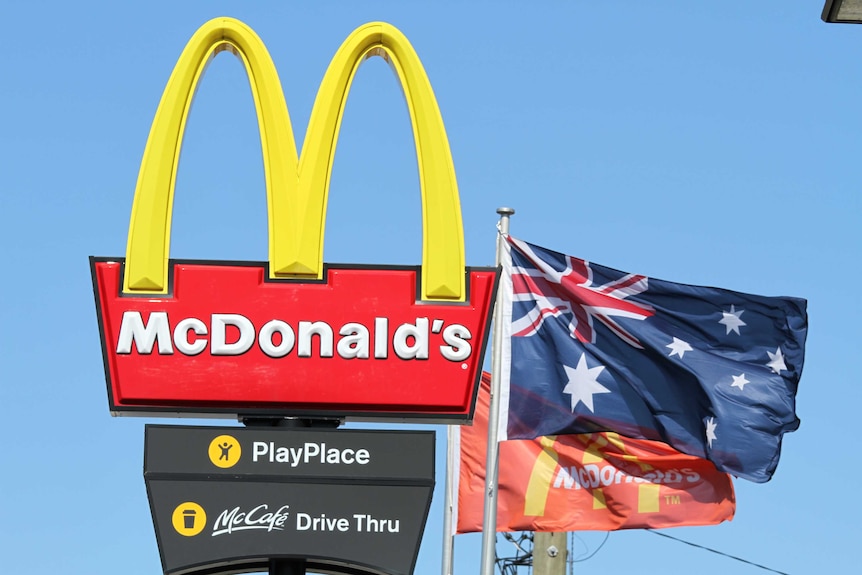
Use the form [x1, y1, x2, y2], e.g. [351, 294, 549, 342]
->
[123, 18, 466, 301]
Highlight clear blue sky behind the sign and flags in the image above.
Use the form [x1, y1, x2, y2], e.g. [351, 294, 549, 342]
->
[0, 0, 862, 575]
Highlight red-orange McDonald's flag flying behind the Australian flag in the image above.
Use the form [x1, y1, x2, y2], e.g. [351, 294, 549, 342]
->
[456, 373, 736, 533]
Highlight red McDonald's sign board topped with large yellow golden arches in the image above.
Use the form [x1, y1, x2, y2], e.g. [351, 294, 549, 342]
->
[90, 18, 497, 422]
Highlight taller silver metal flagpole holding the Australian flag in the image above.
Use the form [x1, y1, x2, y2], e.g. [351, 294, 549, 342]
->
[479, 207, 515, 575]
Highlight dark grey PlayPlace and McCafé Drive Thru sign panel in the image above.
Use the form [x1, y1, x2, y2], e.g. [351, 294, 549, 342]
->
[144, 425, 434, 575]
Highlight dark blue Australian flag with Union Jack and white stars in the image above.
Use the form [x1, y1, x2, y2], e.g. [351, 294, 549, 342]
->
[500, 236, 807, 483]
